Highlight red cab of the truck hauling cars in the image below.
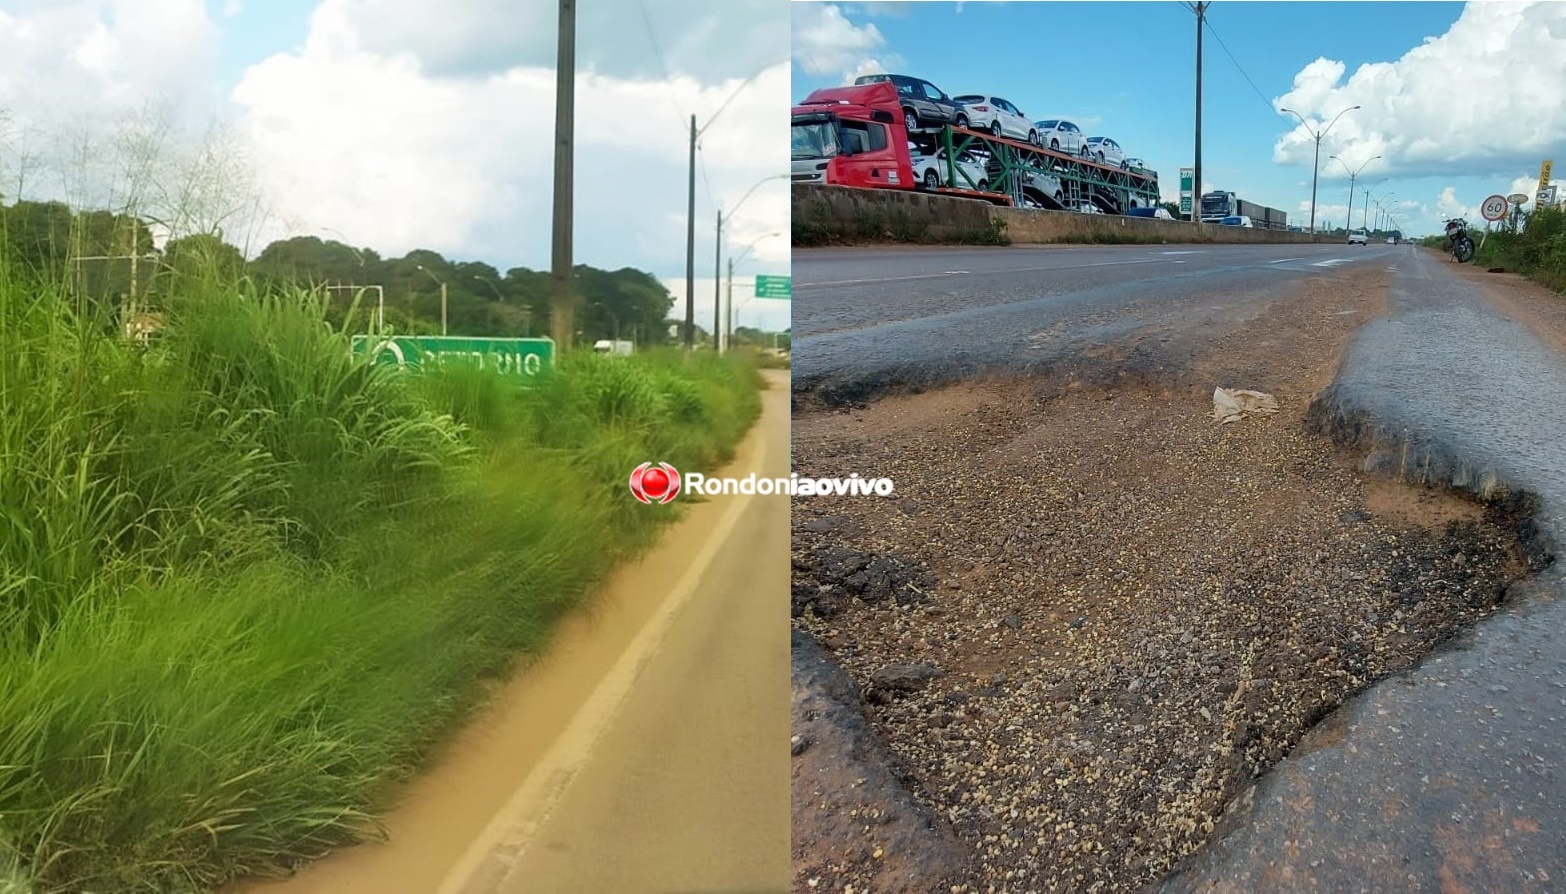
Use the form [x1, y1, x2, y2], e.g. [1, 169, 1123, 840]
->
[789, 81, 918, 189]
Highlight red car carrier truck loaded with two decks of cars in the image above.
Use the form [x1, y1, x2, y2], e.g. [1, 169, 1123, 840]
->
[789, 81, 1159, 214]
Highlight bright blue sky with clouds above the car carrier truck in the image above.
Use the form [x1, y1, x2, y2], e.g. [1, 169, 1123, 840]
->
[792, 0, 1566, 235]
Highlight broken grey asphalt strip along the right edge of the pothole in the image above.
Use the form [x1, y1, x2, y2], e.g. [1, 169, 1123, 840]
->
[1162, 252, 1566, 894]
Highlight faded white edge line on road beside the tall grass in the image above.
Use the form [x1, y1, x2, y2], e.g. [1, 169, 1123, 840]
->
[438, 435, 766, 894]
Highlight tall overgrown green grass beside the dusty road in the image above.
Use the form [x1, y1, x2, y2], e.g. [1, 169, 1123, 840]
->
[0, 255, 760, 894]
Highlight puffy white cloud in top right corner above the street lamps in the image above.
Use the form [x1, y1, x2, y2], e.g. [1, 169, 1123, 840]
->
[1273, 0, 1566, 175]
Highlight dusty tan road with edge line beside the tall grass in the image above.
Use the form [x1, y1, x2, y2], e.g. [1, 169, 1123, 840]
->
[240, 373, 789, 894]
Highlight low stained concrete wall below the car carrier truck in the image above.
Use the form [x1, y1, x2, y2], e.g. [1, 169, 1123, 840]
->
[792, 183, 1325, 244]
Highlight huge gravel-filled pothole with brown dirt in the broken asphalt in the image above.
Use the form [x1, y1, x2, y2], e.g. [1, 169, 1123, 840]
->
[792, 271, 1528, 891]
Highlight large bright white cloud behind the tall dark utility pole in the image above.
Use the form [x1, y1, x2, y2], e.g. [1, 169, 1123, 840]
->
[233, 0, 789, 271]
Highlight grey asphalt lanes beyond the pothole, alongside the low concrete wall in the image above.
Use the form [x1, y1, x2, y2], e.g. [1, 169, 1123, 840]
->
[792, 243, 1416, 404]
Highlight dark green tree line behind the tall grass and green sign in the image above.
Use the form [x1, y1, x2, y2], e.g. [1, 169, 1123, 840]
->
[0, 200, 689, 344]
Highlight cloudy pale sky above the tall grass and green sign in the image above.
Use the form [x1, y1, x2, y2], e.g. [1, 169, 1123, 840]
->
[0, 0, 789, 329]
